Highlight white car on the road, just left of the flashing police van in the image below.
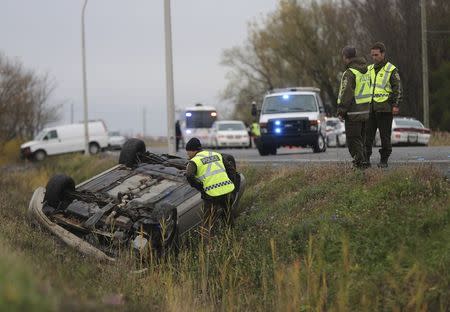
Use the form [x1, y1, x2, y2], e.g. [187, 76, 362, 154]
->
[210, 120, 250, 148]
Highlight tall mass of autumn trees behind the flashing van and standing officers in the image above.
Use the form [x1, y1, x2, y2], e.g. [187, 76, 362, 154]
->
[221, 0, 450, 131]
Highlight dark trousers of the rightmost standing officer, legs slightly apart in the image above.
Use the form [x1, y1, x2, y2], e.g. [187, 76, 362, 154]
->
[364, 112, 393, 163]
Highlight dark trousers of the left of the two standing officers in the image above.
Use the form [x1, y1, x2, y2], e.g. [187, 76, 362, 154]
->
[345, 119, 367, 166]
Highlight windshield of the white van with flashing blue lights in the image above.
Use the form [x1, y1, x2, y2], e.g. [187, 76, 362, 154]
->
[262, 94, 317, 114]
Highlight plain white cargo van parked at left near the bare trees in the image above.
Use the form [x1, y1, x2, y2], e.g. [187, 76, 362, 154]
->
[20, 121, 109, 161]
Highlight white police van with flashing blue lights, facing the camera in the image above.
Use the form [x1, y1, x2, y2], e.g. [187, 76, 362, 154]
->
[252, 87, 327, 156]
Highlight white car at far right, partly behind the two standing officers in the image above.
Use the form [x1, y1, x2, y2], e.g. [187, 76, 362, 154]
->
[374, 117, 431, 146]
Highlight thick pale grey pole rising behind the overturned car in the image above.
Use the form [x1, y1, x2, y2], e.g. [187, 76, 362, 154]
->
[163, 0, 175, 154]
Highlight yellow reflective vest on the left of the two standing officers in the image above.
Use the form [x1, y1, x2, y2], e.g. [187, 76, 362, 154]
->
[337, 68, 372, 115]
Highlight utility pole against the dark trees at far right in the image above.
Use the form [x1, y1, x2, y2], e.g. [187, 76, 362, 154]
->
[420, 0, 430, 128]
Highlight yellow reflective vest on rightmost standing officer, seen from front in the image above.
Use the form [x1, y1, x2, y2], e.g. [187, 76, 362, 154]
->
[367, 62, 396, 103]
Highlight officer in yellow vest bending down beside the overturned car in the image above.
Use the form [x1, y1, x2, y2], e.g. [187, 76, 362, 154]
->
[186, 138, 236, 229]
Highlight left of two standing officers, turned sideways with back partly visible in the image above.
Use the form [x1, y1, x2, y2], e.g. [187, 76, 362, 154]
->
[337, 46, 372, 169]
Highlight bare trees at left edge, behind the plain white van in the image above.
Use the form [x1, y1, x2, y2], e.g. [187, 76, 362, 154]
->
[0, 54, 60, 142]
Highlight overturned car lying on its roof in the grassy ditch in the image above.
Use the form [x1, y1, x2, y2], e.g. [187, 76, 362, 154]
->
[29, 139, 245, 261]
